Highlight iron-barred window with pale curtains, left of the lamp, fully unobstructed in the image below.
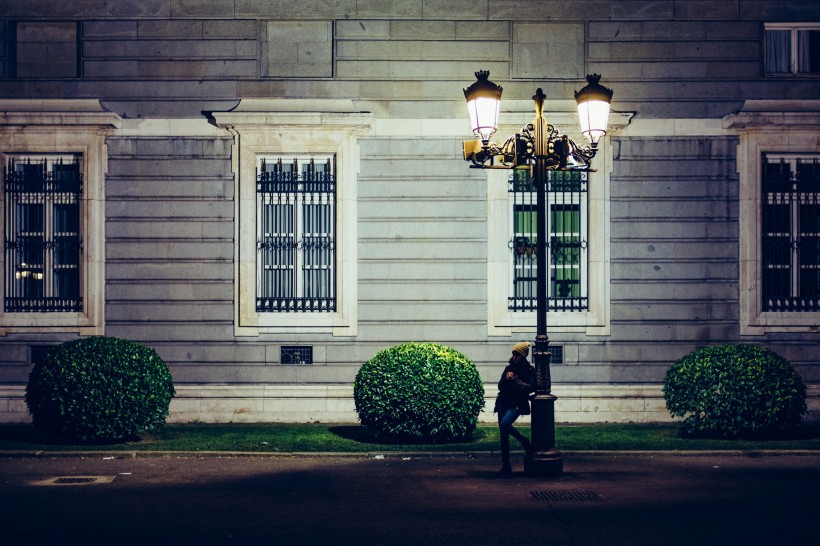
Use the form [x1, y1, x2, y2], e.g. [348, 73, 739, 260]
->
[256, 155, 336, 312]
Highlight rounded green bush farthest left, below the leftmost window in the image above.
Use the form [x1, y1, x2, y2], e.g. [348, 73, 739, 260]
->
[26, 337, 176, 442]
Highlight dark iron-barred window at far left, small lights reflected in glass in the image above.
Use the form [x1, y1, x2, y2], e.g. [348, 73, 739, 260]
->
[3, 154, 83, 313]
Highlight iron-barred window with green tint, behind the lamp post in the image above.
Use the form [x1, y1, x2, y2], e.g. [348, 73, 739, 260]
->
[508, 170, 589, 311]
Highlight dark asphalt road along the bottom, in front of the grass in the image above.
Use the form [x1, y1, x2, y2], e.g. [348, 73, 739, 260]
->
[0, 455, 820, 546]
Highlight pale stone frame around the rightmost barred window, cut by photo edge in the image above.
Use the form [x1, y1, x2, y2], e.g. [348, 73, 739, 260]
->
[724, 101, 820, 335]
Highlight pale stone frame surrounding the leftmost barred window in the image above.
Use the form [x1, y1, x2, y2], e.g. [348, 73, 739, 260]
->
[0, 100, 122, 335]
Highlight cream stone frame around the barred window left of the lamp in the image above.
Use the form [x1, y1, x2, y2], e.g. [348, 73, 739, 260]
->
[211, 104, 373, 336]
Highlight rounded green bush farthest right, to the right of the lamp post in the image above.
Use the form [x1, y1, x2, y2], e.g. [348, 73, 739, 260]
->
[663, 344, 806, 437]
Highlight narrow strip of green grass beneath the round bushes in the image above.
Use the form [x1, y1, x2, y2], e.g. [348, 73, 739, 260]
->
[0, 423, 820, 454]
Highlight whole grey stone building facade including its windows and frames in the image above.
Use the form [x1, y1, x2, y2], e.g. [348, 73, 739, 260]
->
[0, 0, 820, 422]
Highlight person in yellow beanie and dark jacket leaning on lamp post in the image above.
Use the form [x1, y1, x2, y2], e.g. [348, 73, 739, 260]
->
[493, 341, 536, 474]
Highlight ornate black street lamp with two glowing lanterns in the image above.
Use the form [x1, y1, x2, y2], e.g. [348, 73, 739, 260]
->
[464, 71, 612, 476]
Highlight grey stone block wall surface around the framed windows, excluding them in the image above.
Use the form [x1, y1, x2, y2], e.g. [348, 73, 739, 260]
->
[0, 0, 820, 421]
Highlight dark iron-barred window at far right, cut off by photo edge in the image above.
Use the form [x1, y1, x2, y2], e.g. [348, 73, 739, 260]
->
[761, 154, 820, 311]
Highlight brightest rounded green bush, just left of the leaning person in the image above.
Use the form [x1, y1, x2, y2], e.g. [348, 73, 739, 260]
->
[353, 343, 484, 442]
